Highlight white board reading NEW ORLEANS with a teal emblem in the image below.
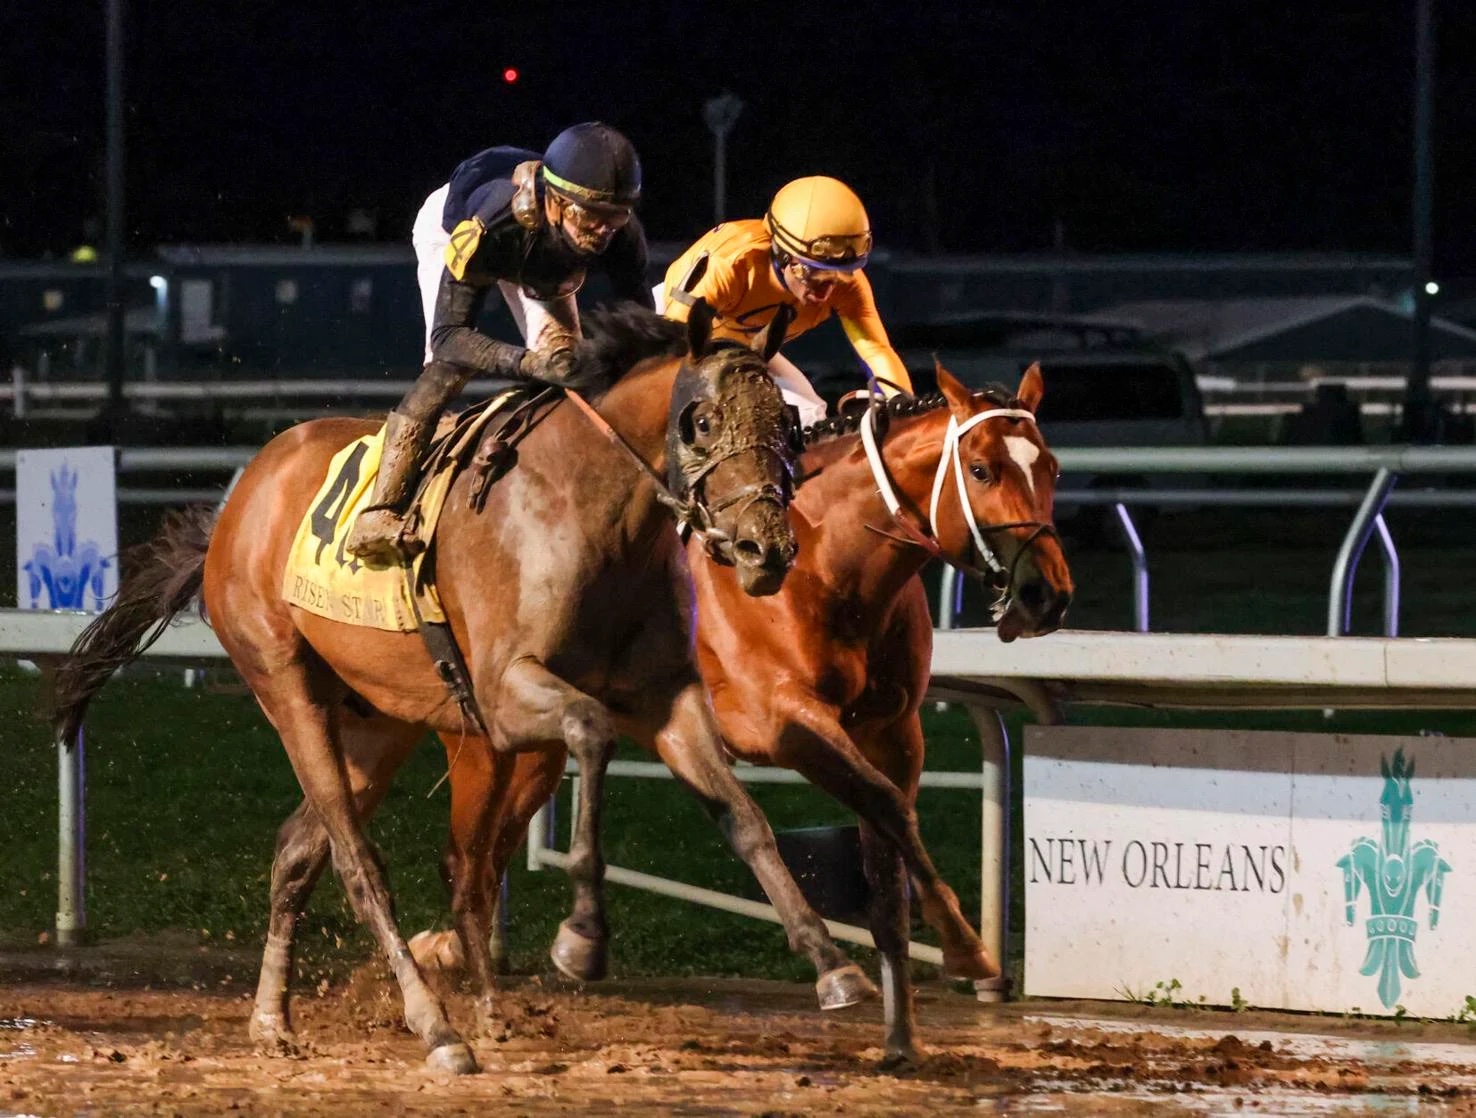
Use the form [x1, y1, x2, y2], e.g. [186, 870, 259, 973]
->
[1023, 727, 1476, 1018]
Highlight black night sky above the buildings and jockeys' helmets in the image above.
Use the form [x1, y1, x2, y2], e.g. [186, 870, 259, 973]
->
[0, 0, 1476, 275]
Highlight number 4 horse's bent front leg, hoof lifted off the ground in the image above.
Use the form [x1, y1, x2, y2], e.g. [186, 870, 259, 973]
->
[496, 657, 617, 982]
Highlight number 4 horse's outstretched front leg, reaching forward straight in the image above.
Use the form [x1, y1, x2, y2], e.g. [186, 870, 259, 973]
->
[643, 682, 877, 1009]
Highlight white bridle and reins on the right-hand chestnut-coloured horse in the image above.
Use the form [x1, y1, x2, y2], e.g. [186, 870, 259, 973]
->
[861, 397, 1055, 620]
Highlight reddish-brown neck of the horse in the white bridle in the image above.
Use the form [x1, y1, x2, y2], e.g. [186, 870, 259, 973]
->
[794, 412, 948, 606]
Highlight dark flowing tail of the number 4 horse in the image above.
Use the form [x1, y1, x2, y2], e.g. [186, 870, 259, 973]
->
[50, 505, 215, 744]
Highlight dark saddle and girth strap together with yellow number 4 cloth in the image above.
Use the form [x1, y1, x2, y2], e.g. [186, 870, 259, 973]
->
[282, 387, 562, 722]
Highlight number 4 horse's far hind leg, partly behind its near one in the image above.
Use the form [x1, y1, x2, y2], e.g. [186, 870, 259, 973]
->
[249, 715, 421, 1053]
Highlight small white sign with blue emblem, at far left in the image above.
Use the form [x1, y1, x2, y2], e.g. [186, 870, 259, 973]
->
[15, 446, 118, 610]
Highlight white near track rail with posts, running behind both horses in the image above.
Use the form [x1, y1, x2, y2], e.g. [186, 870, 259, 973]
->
[0, 610, 1476, 997]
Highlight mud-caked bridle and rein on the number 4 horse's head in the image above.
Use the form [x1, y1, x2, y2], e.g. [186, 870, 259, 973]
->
[564, 352, 790, 567]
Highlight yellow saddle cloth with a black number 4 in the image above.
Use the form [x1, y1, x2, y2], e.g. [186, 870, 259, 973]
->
[282, 393, 511, 632]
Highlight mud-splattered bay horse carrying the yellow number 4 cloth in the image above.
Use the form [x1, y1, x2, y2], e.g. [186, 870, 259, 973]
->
[53, 307, 874, 1074]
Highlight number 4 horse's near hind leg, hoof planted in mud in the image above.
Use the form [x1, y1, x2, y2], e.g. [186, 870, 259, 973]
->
[252, 665, 477, 1074]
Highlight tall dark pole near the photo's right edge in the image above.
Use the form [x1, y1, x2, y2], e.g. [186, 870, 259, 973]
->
[1404, 0, 1438, 443]
